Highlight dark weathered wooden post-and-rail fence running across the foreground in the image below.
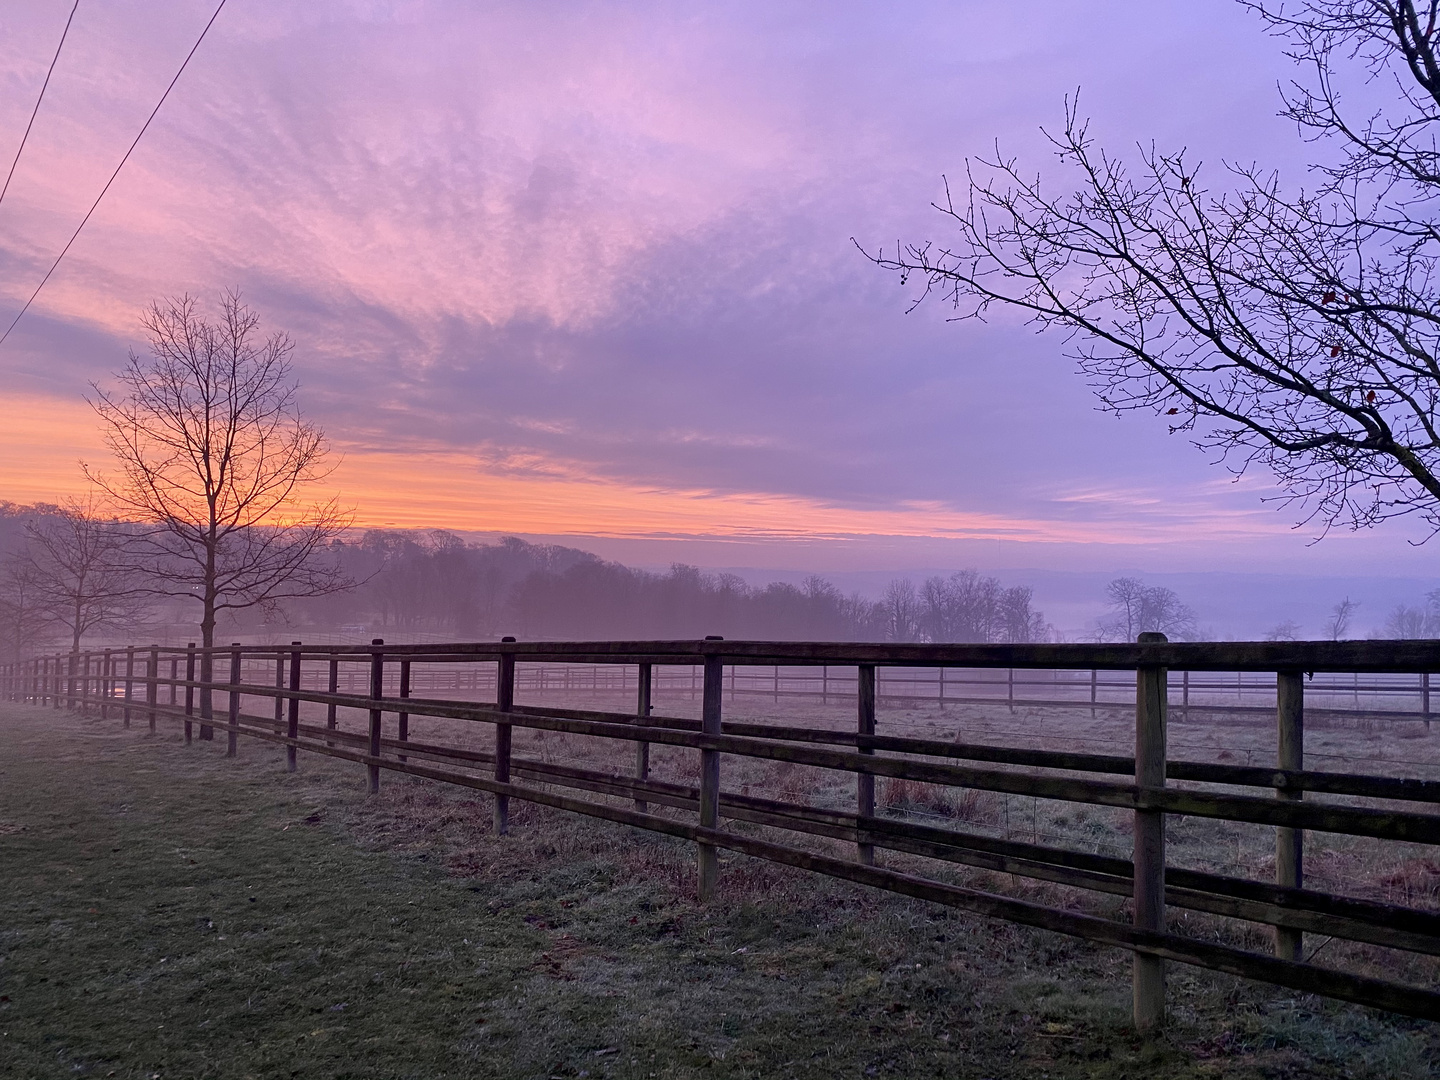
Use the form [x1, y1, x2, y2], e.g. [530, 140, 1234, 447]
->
[0, 635, 1440, 1028]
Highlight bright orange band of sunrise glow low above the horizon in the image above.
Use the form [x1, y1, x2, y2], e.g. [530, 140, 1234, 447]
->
[0, 396, 1283, 544]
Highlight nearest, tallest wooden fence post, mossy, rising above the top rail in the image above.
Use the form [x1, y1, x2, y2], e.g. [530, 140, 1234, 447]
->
[1133, 634, 1168, 1031]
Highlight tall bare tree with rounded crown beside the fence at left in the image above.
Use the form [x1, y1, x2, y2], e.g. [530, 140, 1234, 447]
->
[86, 292, 350, 731]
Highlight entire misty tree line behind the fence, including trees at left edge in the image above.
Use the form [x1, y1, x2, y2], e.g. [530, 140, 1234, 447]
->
[0, 504, 1051, 657]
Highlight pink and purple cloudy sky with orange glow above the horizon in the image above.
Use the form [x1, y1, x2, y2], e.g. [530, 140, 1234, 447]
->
[0, 0, 1436, 587]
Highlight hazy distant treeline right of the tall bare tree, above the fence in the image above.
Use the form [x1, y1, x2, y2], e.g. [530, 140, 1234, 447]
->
[289, 530, 1050, 642]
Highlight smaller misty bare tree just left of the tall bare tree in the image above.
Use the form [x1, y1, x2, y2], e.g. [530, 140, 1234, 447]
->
[19, 500, 147, 652]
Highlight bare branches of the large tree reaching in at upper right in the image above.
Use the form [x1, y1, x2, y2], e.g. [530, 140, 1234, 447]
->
[871, 0, 1440, 530]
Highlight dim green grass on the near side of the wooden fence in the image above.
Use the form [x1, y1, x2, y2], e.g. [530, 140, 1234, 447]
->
[0, 706, 1440, 1080]
